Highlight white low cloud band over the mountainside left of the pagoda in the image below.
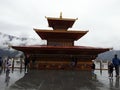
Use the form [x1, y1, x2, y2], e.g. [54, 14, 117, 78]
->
[0, 33, 41, 48]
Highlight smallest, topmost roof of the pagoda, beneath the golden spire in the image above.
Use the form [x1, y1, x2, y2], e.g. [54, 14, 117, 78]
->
[46, 16, 77, 30]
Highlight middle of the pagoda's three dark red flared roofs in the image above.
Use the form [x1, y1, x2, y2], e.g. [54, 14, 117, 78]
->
[34, 29, 88, 40]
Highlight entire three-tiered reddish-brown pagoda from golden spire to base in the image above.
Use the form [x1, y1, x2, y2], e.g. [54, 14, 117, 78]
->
[12, 14, 110, 70]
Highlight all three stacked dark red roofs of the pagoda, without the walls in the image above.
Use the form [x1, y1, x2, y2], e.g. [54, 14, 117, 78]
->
[12, 13, 110, 59]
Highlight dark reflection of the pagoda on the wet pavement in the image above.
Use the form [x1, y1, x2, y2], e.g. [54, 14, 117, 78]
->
[11, 70, 102, 90]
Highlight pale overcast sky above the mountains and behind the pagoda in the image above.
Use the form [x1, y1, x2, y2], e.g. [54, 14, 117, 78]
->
[0, 0, 120, 49]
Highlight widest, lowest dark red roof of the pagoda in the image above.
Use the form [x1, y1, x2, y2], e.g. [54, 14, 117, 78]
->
[12, 45, 110, 56]
